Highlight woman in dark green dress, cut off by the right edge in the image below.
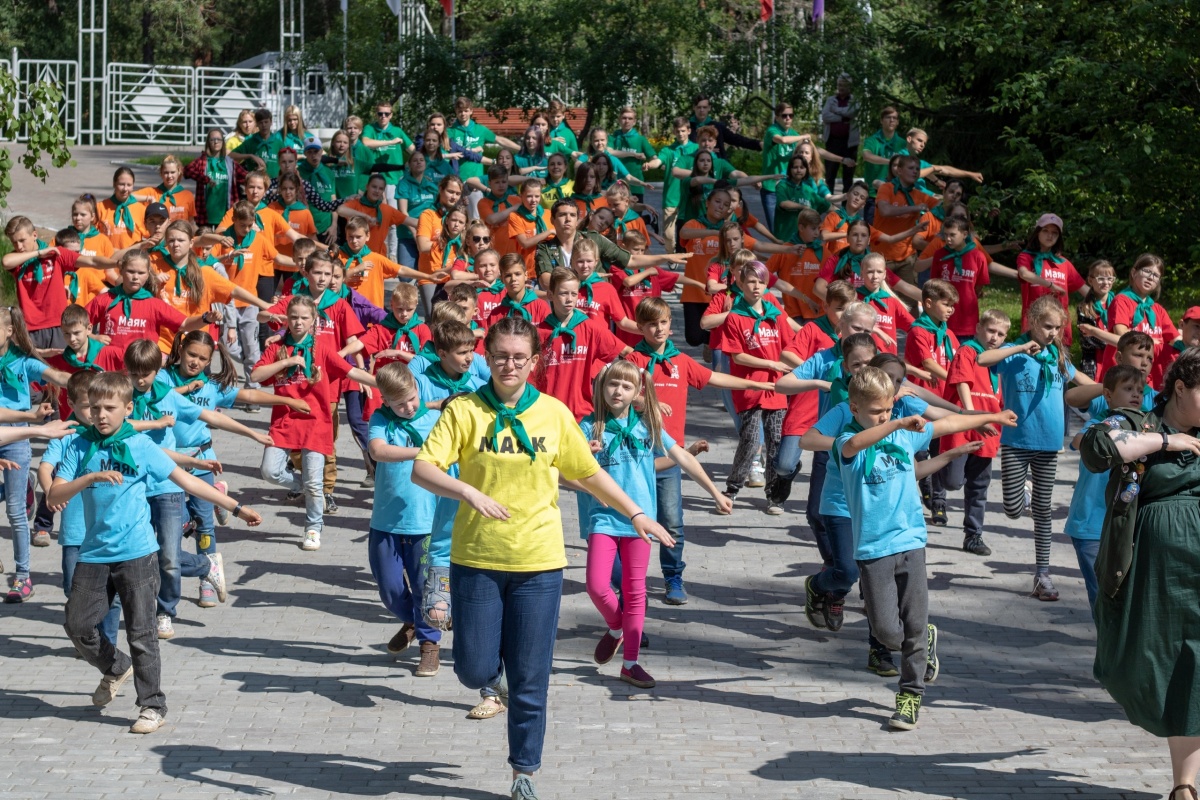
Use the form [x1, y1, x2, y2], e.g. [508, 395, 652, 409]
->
[1080, 348, 1200, 800]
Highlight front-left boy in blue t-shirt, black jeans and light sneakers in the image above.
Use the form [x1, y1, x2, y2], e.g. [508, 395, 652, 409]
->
[47, 372, 263, 733]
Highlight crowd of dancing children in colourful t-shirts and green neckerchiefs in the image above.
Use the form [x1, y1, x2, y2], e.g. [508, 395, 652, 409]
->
[0, 103, 1185, 733]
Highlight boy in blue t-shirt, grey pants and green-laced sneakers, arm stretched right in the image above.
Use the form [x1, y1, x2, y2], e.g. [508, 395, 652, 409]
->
[832, 367, 1016, 730]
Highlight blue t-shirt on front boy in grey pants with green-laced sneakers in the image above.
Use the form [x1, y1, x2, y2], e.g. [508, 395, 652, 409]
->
[829, 422, 934, 561]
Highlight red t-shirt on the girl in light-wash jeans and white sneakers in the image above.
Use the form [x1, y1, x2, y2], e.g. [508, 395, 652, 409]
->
[254, 336, 350, 456]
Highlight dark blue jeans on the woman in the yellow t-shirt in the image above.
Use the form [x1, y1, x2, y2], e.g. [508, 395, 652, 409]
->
[450, 564, 563, 772]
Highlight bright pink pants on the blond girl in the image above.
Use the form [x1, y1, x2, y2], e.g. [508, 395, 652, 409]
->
[588, 534, 650, 661]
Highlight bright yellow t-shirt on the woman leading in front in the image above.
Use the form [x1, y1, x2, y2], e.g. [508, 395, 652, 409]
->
[416, 393, 600, 572]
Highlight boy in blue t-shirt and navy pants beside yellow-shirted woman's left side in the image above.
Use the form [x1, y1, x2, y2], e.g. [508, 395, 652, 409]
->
[367, 361, 442, 678]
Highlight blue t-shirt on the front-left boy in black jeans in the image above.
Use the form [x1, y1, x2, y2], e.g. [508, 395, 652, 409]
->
[58, 433, 179, 564]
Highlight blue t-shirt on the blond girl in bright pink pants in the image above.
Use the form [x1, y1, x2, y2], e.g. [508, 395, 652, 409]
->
[577, 416, 676, 539]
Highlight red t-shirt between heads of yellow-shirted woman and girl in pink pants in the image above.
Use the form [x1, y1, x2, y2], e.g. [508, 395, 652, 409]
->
[533, 314, 624, 422]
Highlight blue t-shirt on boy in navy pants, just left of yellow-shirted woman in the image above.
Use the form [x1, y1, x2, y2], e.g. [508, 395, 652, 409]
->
[367, 409, 442, 536]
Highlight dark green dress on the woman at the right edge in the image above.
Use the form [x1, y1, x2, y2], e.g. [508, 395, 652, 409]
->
[1080, 409, 1200, 736]
